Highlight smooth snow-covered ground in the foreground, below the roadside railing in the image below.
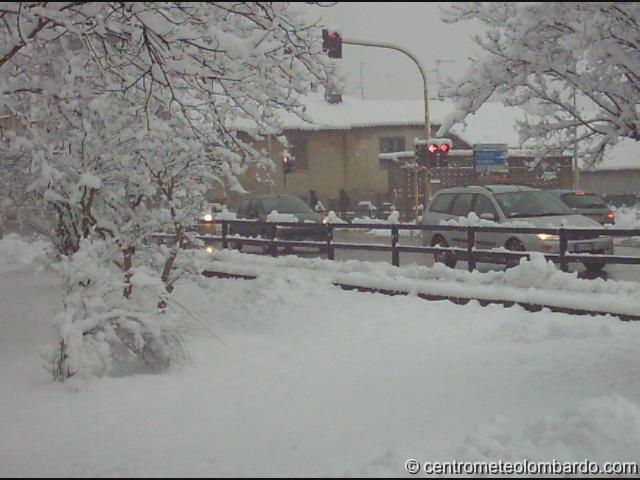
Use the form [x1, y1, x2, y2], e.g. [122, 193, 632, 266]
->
[0, 237, 640, 477]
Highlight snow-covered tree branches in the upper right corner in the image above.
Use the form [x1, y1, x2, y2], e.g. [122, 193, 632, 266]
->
[438, 2, 640, 164]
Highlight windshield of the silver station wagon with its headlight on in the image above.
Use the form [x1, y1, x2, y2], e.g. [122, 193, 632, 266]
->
[495, 190, 573, 218]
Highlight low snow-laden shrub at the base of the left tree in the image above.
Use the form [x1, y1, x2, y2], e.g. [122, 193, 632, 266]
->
[47, 240, 187, 381]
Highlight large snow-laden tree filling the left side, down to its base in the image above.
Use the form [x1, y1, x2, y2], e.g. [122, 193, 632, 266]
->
[0, 2, 334, 378]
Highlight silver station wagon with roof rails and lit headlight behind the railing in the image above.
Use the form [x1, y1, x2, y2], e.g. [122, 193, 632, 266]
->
[422, 185, 613, 271]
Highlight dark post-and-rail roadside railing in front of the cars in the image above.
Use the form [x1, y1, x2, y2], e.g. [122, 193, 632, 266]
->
[176, 220, 640, 272]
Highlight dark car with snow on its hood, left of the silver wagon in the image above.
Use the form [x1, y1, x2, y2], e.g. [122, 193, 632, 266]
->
[229, 195, 327, 250]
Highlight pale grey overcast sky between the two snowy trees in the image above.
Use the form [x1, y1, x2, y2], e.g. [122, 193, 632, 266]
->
[308, 2, 482, 99]
